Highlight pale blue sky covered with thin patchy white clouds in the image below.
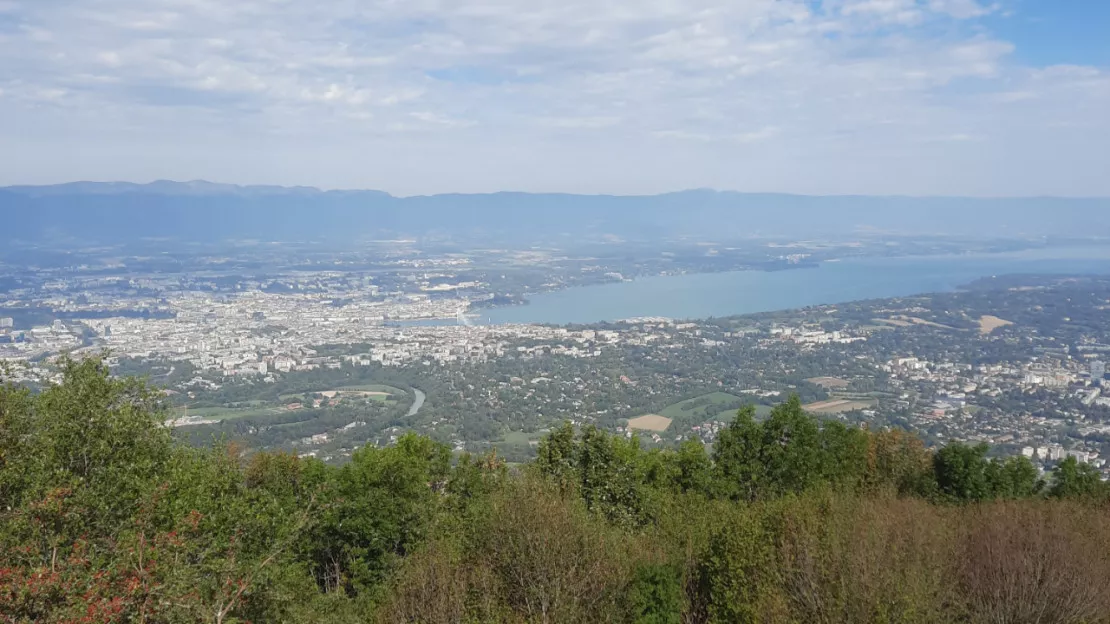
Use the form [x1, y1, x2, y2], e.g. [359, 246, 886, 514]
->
[0, 0, 1110, 197]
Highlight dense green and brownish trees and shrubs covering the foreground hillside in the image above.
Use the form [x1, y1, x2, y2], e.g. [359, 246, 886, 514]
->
[0, 360, 1110, 624]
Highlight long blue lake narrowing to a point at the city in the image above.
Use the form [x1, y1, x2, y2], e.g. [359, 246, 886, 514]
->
[476, 248, 1110, 324]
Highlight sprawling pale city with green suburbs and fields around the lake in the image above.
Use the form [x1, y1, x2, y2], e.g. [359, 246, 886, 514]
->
[0, 238, 1110, 481]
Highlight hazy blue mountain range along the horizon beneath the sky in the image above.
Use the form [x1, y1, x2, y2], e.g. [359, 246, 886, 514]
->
[0, 181, 1110, 243]
